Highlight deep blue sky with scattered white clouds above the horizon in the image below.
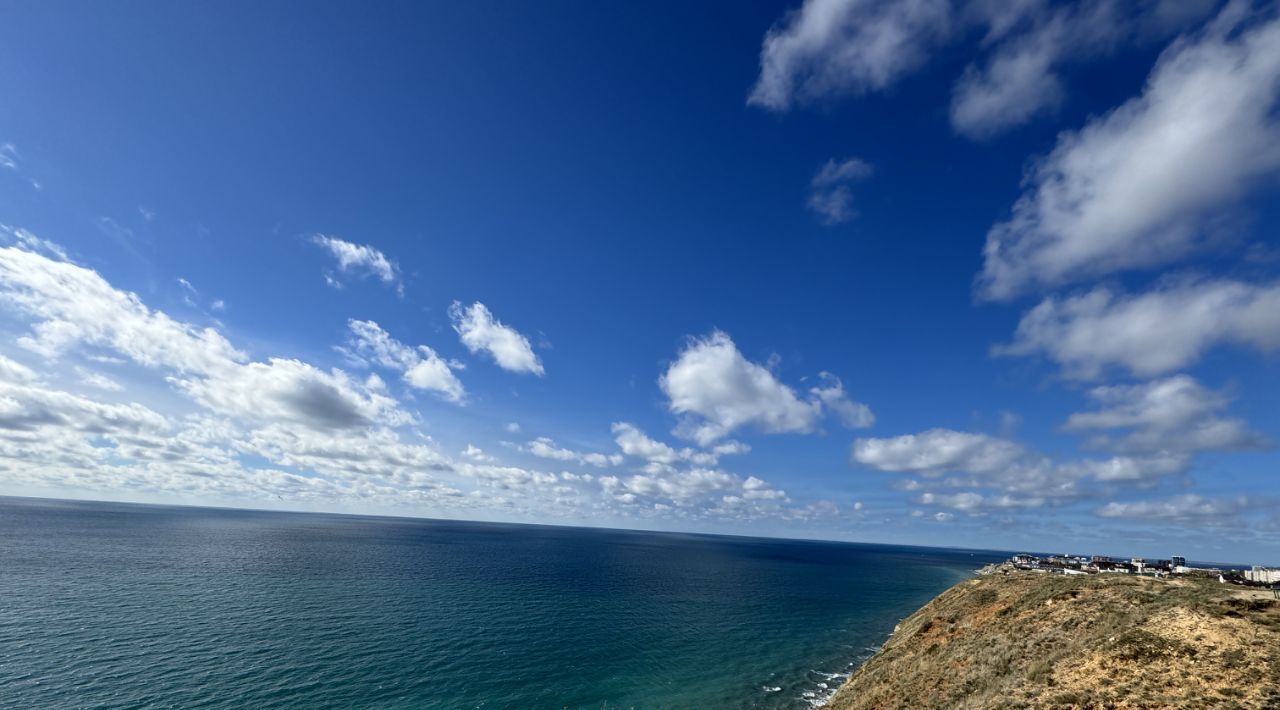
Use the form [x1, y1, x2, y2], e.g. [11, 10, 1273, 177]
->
[0, 0, 1280, 563]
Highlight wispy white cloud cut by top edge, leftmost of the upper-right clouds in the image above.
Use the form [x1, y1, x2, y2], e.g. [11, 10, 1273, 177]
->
[749, 0, 951, 110]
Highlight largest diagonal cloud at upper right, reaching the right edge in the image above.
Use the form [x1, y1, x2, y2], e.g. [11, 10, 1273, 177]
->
[978, 3, 1280, 299]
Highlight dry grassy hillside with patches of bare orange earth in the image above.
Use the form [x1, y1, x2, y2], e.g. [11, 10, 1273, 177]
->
[829, 572, 1280, 710]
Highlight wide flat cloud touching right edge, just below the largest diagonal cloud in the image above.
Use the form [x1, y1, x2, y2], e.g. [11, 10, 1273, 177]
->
[996, 280, 1280, 379]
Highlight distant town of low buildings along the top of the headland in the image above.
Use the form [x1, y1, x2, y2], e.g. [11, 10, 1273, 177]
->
[984, 553, 1280, 587]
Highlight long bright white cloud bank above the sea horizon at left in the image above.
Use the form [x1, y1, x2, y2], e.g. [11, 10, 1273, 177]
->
[0, 230, 855, 523]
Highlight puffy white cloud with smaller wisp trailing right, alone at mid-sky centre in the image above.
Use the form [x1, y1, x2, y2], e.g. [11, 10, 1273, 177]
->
[658, 330, 872, 446]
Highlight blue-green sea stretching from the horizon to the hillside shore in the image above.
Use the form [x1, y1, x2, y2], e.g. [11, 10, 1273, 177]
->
[0, 498, 1004, 709]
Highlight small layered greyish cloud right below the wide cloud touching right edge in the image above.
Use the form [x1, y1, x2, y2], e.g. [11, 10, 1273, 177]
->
[1066, 375, 1266, 454]
